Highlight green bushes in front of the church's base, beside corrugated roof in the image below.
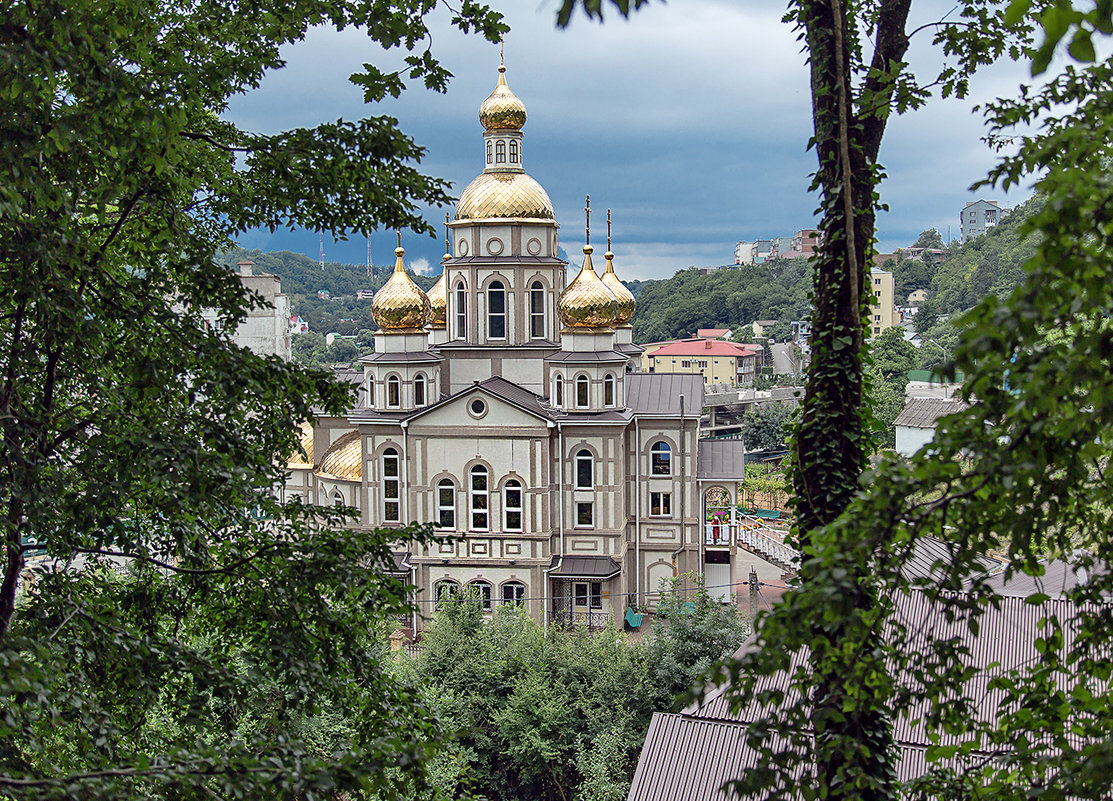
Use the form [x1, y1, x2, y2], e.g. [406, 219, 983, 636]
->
[408, 576, 749, 801]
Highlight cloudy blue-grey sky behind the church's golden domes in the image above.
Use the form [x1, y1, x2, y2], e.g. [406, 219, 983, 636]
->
[226, 0, 1030, 279]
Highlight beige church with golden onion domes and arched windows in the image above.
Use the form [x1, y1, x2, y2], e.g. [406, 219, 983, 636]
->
[284, 57, 749, 633]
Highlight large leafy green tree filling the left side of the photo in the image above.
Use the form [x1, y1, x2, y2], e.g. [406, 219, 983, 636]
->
[0, 0, 504, 799]
